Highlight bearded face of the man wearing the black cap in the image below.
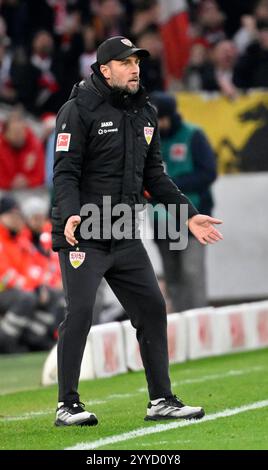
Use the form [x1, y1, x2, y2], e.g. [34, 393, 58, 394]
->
[100, 54, 140, 95]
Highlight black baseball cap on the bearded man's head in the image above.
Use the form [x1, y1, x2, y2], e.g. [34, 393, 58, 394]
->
[97, 36, 150, 65]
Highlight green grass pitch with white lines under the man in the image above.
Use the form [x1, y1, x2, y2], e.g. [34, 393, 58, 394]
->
[0, 349, 268, 450]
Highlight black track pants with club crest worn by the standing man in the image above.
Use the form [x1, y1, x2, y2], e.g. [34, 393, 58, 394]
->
[58, 239, 171, 402]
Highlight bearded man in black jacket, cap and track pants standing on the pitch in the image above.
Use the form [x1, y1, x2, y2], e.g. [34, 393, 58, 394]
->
[52, 36, 222, 426]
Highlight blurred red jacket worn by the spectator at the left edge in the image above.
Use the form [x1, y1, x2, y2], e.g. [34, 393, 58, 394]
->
[0, 128, 45, 189]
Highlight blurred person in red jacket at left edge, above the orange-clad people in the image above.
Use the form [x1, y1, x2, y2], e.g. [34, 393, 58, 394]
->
[0, 111, 44, 190]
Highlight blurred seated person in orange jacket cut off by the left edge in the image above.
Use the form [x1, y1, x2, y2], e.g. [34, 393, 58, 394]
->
[0, 196, 37, 353]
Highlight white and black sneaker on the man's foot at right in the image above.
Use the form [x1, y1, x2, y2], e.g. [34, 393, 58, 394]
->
[144, 395, 205, 421]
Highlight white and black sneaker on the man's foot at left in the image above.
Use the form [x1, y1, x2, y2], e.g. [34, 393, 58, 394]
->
[55, 402, 98, 426]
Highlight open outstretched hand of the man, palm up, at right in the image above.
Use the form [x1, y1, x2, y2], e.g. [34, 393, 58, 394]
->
[187, 214, 223, 245]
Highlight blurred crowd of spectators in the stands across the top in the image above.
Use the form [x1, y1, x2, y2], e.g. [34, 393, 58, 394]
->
[0, 0, 268, 116]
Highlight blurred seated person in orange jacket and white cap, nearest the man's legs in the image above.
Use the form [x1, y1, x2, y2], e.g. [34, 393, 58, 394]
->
[19, 196, 65, 350]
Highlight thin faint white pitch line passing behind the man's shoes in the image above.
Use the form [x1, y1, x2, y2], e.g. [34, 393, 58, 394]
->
[0, 366, 266, 422]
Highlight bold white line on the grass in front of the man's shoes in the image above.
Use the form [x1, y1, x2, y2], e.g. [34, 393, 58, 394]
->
[65, 400, 268, 450]
